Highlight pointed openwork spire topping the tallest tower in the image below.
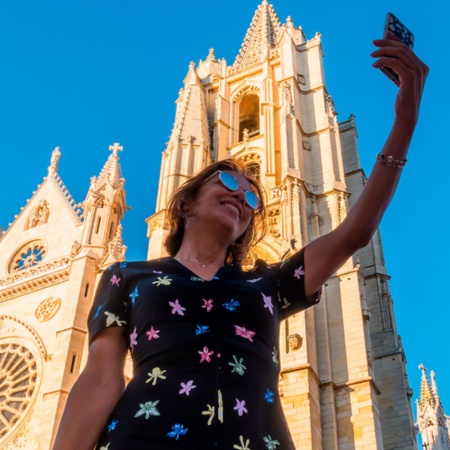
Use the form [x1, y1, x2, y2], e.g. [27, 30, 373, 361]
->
[234, 0, 281, 69]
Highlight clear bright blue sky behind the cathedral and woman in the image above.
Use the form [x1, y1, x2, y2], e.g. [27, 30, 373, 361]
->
[0, 0, 450, 436]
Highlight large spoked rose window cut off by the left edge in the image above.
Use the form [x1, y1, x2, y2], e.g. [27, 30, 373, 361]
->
[0, 344, 37, 439]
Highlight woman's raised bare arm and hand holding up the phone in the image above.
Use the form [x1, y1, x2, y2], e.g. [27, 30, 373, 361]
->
[305, 33, 428, 296]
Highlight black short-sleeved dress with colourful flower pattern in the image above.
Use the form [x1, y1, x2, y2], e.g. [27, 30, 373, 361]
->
[89, 252, 320, 450]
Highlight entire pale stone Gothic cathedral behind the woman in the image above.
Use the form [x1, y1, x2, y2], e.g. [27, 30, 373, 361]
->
[0, 0, 450, 450]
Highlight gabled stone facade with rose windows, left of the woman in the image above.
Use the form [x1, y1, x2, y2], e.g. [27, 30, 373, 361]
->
[0, 144, 128, 450]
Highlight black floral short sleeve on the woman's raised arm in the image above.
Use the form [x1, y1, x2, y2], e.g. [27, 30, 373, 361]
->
[278, 249, 322, 319]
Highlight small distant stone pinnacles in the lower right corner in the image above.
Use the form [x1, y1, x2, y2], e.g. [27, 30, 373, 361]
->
[416, 365, 450, 450]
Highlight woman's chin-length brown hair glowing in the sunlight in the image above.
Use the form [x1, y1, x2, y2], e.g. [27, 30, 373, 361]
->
[164, 159, 266, 264]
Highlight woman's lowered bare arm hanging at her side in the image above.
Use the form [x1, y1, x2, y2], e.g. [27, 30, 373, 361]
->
[53, 328, 127, 450]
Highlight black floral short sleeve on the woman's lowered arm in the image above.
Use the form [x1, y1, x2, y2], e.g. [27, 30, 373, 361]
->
[88, 263, 128, 343]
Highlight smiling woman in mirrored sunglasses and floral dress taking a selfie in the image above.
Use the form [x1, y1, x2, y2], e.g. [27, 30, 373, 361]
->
[54, 34, 428, 450]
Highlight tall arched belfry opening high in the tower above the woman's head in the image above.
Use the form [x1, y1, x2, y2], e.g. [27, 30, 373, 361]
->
[231, 83, 261, 143]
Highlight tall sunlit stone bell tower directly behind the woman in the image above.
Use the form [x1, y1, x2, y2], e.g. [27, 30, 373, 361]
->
[147, 0, 417, 450]
